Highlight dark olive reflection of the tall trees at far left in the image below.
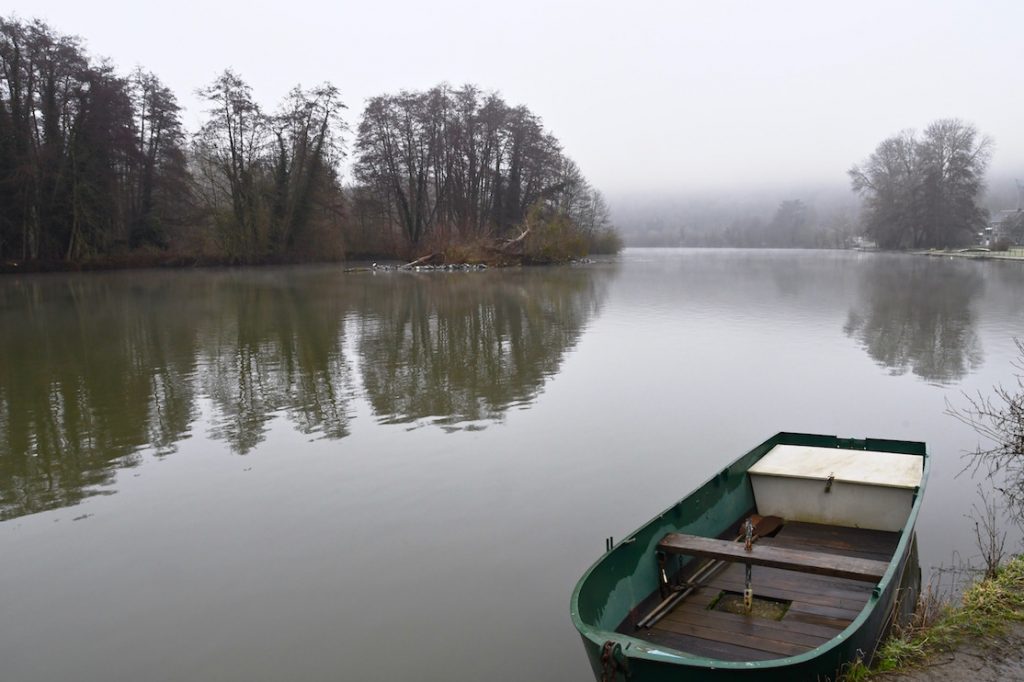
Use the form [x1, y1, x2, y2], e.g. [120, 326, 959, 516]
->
[0, 279, 195, 518]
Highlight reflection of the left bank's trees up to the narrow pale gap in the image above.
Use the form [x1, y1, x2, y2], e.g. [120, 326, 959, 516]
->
[0, 273, 349, 519]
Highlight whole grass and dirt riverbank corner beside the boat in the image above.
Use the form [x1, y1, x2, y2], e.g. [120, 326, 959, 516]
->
[845, 555, 1024, 682]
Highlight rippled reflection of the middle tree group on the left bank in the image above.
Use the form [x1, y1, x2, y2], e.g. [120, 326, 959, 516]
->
[202, 274, 350, 454]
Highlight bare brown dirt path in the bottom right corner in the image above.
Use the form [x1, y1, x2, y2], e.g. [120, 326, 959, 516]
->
[881, 624, 1024, 682]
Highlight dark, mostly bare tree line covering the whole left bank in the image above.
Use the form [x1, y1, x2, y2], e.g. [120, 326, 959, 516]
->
[0, 18, 618, 263]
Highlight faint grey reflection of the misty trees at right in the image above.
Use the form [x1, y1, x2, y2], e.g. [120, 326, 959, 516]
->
[844, 258, 983, 383]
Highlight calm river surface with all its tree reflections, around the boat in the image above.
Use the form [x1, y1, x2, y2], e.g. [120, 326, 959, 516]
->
[0, 250, 1024, 682]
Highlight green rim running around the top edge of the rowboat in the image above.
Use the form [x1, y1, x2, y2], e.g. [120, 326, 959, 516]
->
[569, 431, 931, 670]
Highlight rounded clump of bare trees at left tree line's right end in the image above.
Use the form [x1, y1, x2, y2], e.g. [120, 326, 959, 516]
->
[355, 84, 610, 253]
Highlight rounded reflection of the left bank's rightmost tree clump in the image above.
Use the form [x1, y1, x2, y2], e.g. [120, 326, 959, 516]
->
[359, 268, 604, 423]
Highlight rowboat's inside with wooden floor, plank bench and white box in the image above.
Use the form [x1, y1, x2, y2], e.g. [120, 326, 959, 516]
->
[617, 445, 922, 662]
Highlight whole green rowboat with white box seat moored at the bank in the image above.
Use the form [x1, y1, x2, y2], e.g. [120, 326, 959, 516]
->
[571, 433, 929, 682]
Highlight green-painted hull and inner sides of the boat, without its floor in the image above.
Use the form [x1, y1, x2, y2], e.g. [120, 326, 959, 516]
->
[570, 433, 929, 682]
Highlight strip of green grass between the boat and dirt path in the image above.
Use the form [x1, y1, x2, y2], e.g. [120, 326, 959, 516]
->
[843, 555, 1024, 682]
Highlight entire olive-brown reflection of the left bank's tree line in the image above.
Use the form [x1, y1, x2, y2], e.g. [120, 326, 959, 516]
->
[0, 269, 603, 519]
